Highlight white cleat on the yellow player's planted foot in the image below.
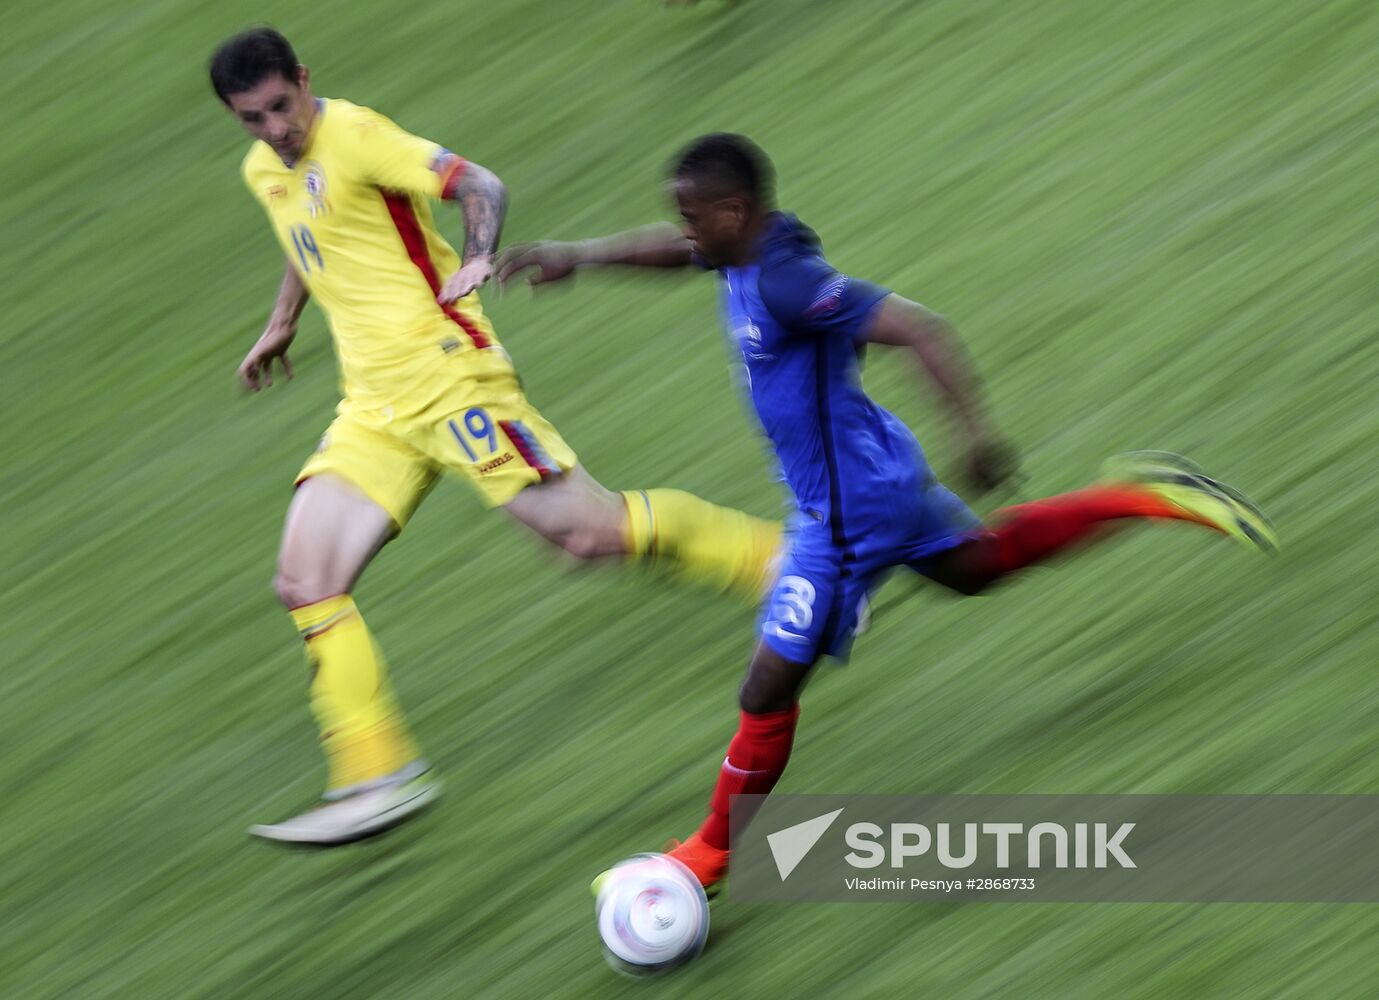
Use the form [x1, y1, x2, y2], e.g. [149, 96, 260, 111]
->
[250, 763, 440, 846]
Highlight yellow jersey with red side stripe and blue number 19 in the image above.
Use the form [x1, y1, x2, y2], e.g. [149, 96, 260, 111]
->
[243, 99, 496, 407]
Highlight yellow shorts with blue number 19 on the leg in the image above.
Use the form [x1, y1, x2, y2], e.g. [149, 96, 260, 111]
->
[296, 348, 578, 530]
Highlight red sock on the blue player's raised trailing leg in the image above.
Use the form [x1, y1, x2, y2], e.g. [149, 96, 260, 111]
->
[982, 486, 1196, 579]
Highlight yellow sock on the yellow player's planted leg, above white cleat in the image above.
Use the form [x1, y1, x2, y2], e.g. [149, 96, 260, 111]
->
[292, 594, 421, 790]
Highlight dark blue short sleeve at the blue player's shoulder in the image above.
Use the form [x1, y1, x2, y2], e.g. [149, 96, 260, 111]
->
[757, 257, 891, 341]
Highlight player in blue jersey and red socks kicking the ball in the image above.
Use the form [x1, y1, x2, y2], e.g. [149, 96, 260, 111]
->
[498, 134, 1274, 887]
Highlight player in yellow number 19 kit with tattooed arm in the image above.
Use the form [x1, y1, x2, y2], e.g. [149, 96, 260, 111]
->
[211, 29, 779, 844]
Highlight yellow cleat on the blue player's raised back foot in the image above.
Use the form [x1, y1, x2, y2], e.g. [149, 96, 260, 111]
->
[1102, 451, 1278, 554]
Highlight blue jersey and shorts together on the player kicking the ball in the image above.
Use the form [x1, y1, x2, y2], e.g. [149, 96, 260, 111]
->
[718, 214, 978, 663]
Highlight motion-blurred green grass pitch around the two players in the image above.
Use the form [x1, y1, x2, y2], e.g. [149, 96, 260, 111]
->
[0, 0, 1379, 999]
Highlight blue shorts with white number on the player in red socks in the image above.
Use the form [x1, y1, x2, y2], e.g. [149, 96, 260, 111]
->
[758, 479, 982, 663]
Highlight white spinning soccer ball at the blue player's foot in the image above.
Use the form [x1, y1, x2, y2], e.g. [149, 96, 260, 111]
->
[594, 854, 709, 975]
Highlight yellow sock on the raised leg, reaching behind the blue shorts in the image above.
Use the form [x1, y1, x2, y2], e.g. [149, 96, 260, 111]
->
[622, 490, 781, 601]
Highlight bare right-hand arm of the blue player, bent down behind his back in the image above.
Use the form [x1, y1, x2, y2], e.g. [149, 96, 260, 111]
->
[863, 295, 1019, 491]
